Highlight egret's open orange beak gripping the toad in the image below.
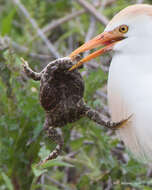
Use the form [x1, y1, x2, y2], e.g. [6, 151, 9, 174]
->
[69, 30, 124, 71]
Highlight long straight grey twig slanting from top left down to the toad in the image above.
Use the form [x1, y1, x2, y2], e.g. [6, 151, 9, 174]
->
[13, 0, 60, 58]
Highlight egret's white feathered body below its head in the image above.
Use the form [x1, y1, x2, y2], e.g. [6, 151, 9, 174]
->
[108, 53, 152, 160]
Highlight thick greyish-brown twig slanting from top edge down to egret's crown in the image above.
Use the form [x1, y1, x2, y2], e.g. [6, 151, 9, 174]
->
[76, 0, 109, 25]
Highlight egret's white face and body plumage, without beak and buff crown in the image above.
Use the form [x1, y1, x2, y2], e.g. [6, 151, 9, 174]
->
[106, 8, 152, 161]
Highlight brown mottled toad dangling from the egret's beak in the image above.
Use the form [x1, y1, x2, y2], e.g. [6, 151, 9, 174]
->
[22, 57, 128, 164]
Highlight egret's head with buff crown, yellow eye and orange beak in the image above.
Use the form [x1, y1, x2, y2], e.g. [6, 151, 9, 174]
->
[70, 4, 152, 70]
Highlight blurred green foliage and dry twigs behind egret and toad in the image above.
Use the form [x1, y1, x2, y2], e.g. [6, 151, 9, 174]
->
[0, 0, 152, 190]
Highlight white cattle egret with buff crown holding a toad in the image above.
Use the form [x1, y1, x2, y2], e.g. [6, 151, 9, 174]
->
[70, 4, 152, 161]
